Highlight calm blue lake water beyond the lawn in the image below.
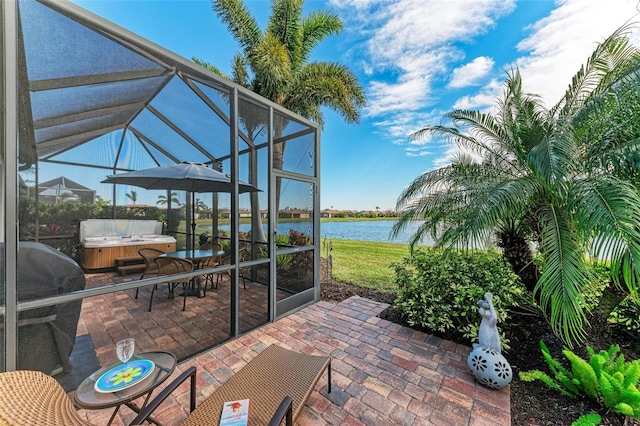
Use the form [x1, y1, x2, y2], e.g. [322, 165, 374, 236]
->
[210, 220, 433, 245]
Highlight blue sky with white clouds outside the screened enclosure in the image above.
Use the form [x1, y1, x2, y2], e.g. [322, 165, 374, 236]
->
[73, 0, 638, 210]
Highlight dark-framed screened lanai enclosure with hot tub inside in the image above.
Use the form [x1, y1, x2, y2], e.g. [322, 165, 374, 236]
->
[0, 0, 320, 380]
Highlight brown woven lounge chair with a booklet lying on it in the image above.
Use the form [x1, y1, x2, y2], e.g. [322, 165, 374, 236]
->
[131, 345, 331, 426]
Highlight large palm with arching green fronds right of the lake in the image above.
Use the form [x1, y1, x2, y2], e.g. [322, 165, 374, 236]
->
[393, 25, 640, 345]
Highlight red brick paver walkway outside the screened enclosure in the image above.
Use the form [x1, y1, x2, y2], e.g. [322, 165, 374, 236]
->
[76, 296, 511, 426]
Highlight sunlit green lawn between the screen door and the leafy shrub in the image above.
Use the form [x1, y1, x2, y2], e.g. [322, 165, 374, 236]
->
[320, 238, 416, 291]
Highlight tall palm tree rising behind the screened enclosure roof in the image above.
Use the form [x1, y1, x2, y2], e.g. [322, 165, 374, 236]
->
[194, 0, 365, 215]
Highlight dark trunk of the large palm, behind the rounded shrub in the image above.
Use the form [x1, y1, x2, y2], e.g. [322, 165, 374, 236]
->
[497, 230, 540, 292]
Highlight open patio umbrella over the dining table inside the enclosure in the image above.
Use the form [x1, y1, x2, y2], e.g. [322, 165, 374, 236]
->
[101, 161, 260, 248]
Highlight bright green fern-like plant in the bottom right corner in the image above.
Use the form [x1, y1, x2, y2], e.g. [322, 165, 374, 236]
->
[520, 340, 640, 418]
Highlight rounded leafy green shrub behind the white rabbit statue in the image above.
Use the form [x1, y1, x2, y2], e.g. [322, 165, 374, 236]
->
[392, 249, 525, 349]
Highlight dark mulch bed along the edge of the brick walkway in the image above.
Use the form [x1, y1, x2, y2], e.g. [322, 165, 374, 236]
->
[320, 280, 640, 426]
